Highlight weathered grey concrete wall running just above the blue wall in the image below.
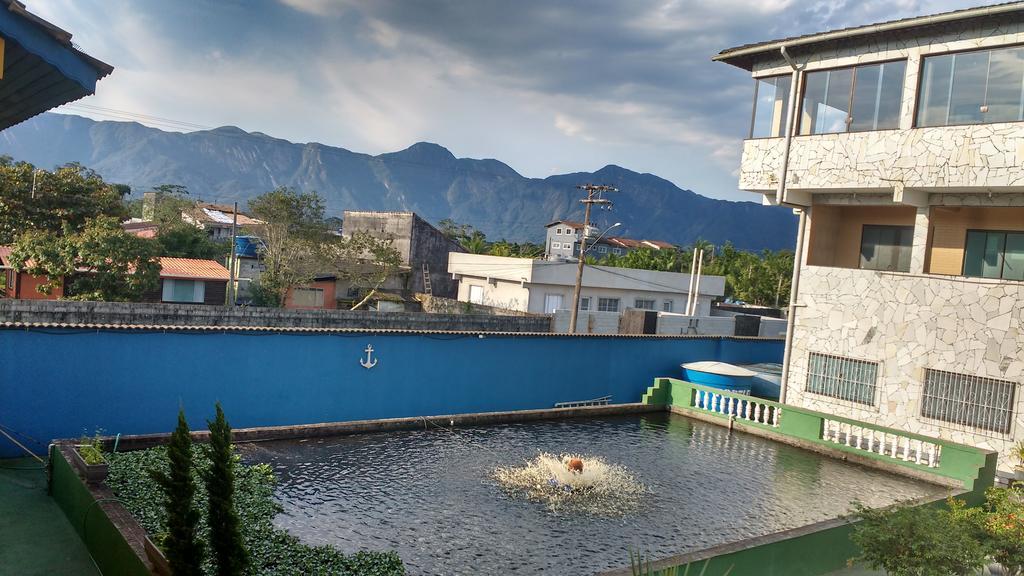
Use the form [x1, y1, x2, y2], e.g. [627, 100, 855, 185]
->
[0, 299, 551, 332]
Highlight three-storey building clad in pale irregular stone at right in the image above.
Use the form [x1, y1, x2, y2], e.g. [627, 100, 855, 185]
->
[715, 3, 1024, 472]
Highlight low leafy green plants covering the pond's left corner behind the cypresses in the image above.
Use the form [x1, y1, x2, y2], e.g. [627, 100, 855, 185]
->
[106, 446, 406, 576]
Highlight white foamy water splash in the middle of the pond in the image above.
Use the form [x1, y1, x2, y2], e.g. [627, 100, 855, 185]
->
[494, 452, 647, 516]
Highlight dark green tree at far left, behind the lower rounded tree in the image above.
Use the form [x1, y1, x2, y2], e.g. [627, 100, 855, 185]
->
[0, 156, 128, 245]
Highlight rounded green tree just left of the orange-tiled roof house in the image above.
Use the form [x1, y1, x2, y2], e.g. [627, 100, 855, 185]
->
[11, 216, 160, 301]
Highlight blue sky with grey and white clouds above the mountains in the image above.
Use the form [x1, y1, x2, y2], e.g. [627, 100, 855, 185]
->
[34, 0, 984, 200]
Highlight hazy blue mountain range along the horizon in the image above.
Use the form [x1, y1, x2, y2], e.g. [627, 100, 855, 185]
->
[0, 114, 796, 250]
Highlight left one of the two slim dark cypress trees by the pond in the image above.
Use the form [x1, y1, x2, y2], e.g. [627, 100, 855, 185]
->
[150, 410, 204, 576]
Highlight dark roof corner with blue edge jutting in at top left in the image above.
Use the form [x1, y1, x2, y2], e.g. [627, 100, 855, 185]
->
[0, 0, 114, 130]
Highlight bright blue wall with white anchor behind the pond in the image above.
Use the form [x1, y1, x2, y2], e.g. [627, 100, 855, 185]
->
[0, 329, 782, 457]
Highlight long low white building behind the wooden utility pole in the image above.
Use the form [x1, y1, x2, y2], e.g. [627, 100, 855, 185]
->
[449, 252, 725, 331]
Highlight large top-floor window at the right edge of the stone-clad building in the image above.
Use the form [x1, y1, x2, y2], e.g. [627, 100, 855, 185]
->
[918, 47, 1024, 126]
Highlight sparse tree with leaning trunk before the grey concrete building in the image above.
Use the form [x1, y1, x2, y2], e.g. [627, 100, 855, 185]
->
[323, 231, 401, 310]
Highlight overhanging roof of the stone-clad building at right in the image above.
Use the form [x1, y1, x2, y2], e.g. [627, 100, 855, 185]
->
[712, 2, 1024, 70]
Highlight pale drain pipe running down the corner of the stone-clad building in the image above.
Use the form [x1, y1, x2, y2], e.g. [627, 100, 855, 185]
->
[775, 44, 807, 404]
